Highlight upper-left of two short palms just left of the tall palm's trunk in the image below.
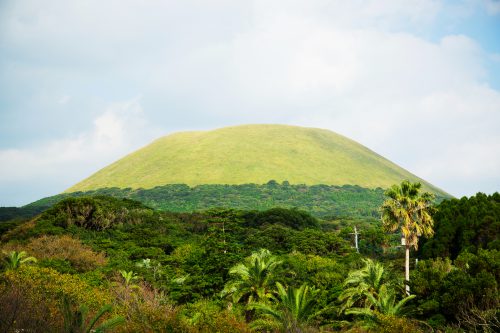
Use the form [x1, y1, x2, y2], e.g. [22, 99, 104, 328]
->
[339, 259, 386, 312]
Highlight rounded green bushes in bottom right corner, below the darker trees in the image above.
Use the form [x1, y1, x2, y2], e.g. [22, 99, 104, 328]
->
[411, 249, 500, 332]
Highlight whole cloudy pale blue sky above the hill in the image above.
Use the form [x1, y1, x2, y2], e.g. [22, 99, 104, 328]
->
[0, 0, 500, 206]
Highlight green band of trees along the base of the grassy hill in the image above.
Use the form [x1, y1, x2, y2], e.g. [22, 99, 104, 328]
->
[19, 180, 384, 218]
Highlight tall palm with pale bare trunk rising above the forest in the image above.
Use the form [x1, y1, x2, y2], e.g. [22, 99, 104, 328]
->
[381, 180, 434, 295]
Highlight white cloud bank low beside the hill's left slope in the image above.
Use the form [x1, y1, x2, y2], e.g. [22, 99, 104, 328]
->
[0, 98, 158, 188]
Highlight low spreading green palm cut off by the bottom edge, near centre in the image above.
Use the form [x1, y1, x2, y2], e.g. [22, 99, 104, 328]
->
[251, 282, 319, 332]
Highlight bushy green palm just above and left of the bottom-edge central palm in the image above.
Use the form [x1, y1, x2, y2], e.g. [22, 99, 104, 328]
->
[221, 249, 281, 320]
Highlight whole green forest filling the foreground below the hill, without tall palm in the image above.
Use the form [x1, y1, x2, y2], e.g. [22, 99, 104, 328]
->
[0, 187, 500, 332]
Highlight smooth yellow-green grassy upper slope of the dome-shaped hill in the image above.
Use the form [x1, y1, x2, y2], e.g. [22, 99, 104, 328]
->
[66, 125, 444, 194]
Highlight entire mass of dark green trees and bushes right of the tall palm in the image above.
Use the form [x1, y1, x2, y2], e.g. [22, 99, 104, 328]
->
[411, 193, 500, 332]
